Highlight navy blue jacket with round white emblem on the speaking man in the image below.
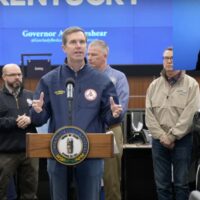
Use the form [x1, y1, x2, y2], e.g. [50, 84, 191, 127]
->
[31, 65, 122, 133]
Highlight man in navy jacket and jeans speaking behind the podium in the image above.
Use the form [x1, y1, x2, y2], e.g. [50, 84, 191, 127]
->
[32, 27, 122, 200]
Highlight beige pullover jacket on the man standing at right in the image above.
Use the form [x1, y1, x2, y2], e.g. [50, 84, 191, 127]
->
[145, 72, 200, 142]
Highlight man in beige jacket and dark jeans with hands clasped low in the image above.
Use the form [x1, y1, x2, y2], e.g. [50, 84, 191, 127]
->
[146, 48, 200, 200]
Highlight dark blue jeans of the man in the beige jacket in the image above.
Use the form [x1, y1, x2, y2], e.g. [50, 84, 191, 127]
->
[152, 134, 192, 200]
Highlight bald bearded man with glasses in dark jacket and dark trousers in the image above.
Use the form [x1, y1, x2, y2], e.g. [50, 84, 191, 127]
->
[0, 64, 38, 200]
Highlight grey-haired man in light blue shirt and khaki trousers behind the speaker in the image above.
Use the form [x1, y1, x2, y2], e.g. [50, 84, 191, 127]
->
[88, 40, 129, 200]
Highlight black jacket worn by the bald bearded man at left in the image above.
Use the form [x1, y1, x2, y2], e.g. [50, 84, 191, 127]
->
[0, 87, 36, 153]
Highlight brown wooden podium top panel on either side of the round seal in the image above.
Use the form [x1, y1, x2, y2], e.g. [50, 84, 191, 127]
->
[26, 133, 114, 158]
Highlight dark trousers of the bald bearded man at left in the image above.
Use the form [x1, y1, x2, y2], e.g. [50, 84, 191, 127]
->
[0, 153, 38, 200]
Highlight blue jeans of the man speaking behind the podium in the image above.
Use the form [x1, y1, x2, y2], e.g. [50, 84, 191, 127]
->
[47, 159, 103, 200]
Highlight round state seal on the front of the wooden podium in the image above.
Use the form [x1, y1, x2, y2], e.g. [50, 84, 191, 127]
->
[50, 126, 89, 165]
